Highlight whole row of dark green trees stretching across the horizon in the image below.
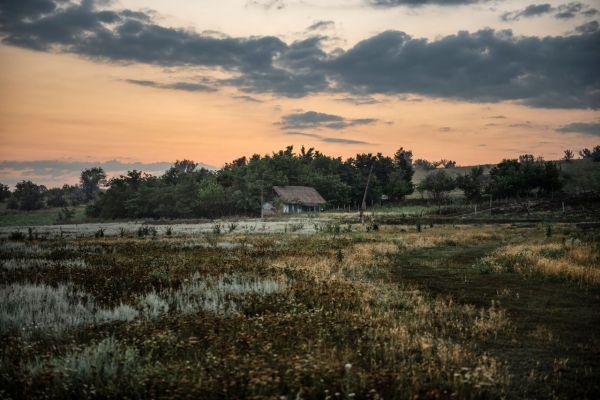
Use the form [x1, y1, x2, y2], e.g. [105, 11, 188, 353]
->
[0, 146, 600, 219]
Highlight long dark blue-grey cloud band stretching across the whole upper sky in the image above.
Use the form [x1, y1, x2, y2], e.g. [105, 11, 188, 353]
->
[0, 0, 600, 109]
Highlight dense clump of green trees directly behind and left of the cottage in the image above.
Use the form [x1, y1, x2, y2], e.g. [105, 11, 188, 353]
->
[88, 146, 414, 218]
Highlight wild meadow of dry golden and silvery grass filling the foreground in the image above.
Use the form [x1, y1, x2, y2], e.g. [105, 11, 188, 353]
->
[0, 222, 600, 399]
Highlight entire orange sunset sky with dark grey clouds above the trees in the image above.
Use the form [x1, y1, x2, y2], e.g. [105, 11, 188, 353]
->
[0, 0, 600, 186]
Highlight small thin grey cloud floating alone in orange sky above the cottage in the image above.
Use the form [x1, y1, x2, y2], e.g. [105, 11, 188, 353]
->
[277, 111, 377, 130]
